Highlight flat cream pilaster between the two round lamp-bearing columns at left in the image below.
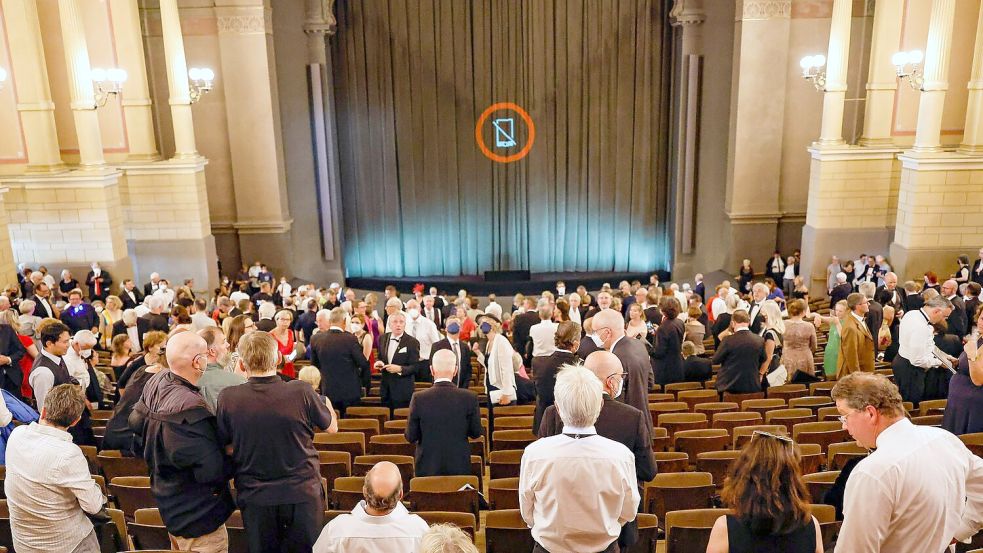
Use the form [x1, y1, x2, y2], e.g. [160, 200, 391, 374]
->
[109, 0, 160, 161]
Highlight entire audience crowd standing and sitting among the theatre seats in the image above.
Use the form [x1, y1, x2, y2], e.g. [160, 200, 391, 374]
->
[0, 249, 983, 553]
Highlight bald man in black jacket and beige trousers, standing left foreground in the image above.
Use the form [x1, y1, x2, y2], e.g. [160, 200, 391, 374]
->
[130, 332, 235, 553]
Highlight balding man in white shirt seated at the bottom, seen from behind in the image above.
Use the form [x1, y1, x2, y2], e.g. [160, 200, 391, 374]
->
[314, 461, 428, 553]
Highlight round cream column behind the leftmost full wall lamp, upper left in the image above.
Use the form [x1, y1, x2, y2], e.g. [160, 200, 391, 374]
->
[58, 0, 106, 169]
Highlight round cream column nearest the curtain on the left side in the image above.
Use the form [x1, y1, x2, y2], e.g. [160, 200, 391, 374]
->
[160, 0, 199, 159]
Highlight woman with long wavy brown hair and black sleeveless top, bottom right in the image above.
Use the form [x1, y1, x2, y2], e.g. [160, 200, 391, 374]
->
[707, 431, 823, 553]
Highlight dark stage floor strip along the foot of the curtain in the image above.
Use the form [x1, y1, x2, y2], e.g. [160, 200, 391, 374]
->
[345, 271, 669, 296]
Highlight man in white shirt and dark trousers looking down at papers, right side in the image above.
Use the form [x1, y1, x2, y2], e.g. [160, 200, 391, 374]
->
[892, 296, 956, 407]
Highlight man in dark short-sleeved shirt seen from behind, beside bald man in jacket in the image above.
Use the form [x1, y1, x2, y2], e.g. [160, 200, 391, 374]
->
[215, 332, 338, 551]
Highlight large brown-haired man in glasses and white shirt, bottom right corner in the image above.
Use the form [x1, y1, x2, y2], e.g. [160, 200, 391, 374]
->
[832, 370, 983, 553]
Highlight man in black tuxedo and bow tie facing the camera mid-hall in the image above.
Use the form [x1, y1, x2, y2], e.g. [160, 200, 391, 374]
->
[375, 312, 420, 409]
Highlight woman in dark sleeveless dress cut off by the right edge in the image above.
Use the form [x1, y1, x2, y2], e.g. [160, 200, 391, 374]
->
[942, 306, 983, 435]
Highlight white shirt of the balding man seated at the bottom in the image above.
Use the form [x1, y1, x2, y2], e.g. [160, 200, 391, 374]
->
[312, 501, 429, 553]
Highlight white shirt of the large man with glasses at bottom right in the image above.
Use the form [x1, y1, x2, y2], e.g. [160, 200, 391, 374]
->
[836, 419, 983, 553]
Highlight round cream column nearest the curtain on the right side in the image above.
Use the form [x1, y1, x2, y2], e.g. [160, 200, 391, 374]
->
[817, 0, 853, 148]
